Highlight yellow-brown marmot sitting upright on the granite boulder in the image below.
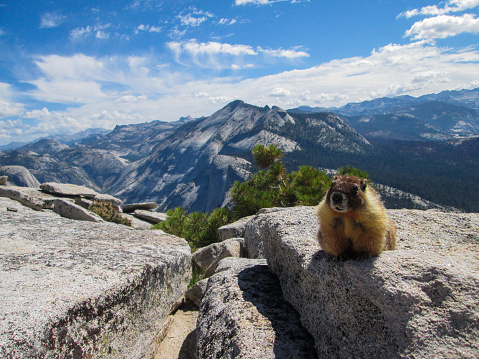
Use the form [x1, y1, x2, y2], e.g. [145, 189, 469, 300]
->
[317, 176, 396, 259]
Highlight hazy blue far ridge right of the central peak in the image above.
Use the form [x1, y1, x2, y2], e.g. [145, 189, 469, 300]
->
[288, 88, 479, 141]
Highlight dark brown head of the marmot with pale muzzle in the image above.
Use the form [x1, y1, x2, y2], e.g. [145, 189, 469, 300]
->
[326, 176, 368, 213]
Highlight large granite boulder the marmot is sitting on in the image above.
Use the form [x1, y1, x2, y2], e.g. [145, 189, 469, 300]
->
[246, 207, 479, 359]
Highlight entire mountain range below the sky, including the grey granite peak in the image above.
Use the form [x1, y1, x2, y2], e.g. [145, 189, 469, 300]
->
[0, 89, 479, 212]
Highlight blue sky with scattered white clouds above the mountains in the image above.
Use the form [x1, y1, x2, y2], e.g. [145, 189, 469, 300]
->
[0, 0, 479, 145]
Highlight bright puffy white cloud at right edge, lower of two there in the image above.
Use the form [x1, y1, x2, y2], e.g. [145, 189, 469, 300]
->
[405, 14, 479, 40]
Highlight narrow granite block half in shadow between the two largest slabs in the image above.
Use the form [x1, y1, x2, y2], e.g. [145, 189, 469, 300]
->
[196, 258, 316, 359]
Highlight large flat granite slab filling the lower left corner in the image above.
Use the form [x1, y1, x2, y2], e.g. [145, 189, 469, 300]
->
[0, 198, 191, 358]
